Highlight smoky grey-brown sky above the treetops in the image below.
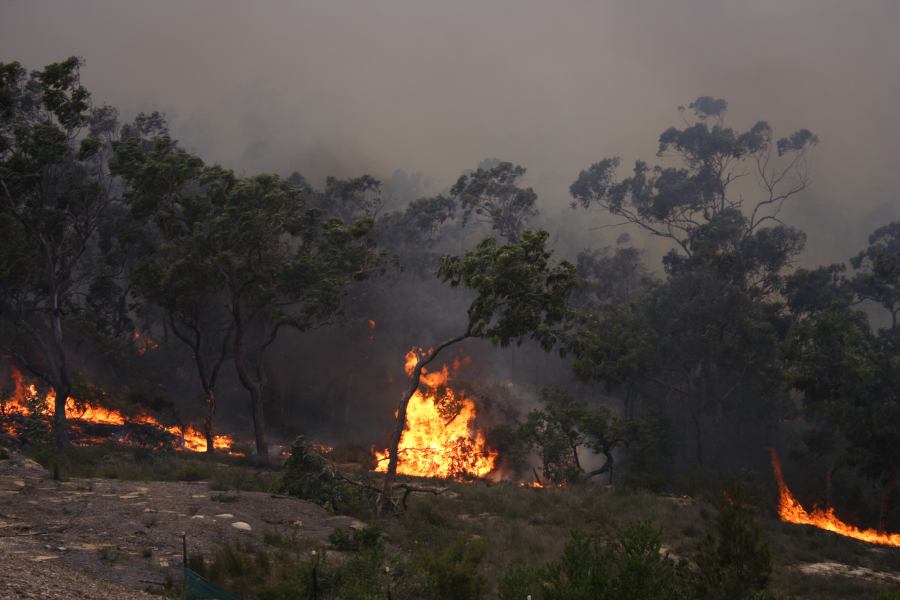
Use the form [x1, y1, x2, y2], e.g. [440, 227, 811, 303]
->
[0, 0, 900, 262]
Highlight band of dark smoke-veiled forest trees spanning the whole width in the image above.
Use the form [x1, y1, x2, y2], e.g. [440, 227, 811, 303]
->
[0, 58, 900, 529]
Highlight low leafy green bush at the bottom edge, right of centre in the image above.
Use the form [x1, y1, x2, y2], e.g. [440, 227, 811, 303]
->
[499, 523, 694, 600]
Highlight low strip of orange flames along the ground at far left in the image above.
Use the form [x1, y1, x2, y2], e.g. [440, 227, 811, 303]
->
[0, 366, 234, 452]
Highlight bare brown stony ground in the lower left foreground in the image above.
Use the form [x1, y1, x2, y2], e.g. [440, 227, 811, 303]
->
[0, 454, 361, 599]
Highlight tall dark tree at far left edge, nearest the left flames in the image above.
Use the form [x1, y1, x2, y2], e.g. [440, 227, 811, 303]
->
[0, 57, 115, 448]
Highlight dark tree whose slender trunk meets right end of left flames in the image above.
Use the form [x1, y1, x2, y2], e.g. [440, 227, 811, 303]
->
[111, 113, 236, 452]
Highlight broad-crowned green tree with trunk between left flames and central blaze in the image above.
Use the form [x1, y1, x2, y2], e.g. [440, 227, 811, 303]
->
[207, 175, 378, 460]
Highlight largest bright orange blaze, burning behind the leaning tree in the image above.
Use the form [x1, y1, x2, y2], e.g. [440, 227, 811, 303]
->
[375, 350, 497, 478]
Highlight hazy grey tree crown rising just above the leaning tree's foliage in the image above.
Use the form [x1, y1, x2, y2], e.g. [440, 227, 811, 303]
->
[450, 161, 537, 242]
